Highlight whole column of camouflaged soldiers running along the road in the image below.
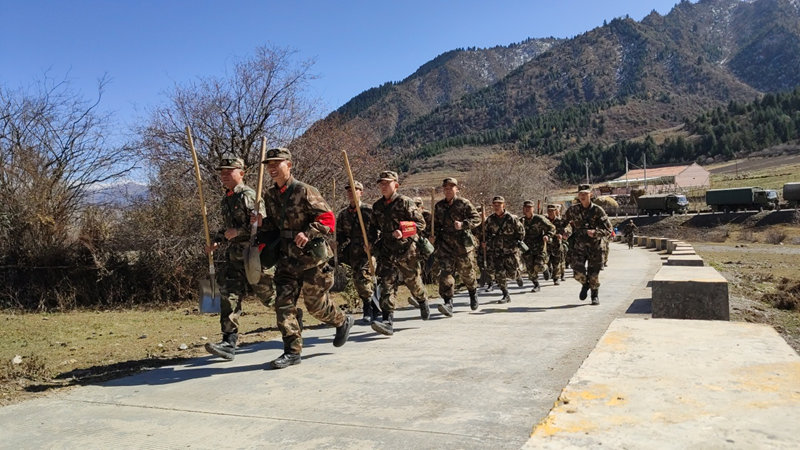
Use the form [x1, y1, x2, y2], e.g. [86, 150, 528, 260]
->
[206, 152, 608, 369]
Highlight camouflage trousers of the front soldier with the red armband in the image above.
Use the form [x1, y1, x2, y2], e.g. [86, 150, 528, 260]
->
[275, 263, 345, 355]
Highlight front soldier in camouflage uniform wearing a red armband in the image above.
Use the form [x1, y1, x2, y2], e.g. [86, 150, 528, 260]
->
[261, 148, 353, 369]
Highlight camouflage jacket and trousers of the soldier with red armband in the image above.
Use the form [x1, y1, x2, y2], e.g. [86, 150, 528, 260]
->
[263, 174, 347, 355]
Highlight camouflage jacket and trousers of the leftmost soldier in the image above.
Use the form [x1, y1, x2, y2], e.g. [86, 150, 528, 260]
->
[214, 183, 268, 341]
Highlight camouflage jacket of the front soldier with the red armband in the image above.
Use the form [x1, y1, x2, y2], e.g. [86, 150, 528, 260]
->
[262, 176, 333, 269]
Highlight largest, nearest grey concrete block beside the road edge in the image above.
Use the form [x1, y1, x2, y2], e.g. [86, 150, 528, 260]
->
[652, 265, 730, 320]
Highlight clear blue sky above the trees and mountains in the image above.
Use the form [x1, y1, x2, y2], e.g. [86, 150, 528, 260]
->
[0, 0, 678, 141]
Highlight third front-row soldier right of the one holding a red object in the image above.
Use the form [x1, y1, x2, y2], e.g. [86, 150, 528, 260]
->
[522, 200, 556, 292]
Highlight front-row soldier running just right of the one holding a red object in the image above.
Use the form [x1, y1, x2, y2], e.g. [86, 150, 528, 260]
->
[433, 178, 481, 317]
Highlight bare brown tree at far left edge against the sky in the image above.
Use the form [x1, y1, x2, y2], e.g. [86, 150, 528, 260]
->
[0, 78, 132, 263]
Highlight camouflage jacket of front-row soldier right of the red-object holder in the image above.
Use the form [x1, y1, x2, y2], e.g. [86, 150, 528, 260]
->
[434, 197, 481, 255]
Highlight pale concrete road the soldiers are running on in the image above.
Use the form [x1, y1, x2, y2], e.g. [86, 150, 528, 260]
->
[0, 243, 661, 449]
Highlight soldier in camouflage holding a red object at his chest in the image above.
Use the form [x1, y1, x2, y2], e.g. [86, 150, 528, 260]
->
[370, 171, 431, 336]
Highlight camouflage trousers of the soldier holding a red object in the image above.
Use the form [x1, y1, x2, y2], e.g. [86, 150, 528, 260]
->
[377, 245, 428, 312]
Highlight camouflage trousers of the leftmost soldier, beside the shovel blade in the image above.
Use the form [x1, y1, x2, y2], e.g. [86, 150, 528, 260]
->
[217, 248, 275, 335]
